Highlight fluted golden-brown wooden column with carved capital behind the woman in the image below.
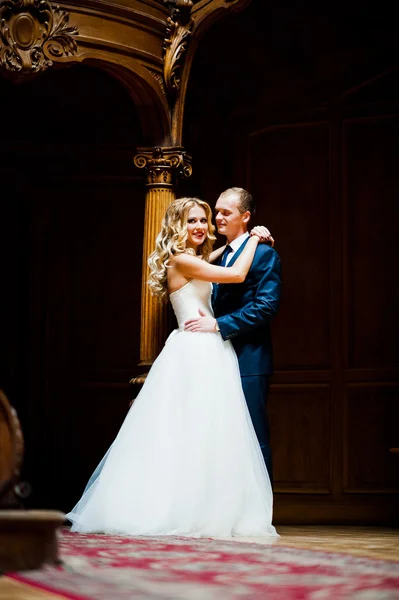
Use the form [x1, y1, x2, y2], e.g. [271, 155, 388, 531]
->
[131, 147, 191, 383]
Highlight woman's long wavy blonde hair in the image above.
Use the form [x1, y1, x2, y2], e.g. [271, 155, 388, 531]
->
[148, 198, 216, 298]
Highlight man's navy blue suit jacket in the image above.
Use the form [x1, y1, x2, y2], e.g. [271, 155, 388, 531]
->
[212, 238, 281, 376]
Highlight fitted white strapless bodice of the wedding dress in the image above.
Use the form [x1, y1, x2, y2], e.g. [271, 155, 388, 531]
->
[169, 279, 213, 329]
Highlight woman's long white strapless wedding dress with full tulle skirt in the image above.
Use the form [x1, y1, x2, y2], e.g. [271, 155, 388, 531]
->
[67, 280, 277, 537]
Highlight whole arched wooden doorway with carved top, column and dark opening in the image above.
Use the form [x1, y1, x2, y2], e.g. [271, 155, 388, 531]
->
[0, 0, 253, 508]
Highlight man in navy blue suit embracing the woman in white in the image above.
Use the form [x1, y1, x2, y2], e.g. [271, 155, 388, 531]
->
[185, 187, 281, 483]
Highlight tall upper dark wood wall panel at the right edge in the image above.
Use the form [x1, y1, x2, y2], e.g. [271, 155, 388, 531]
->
[343, 116, 399, 368]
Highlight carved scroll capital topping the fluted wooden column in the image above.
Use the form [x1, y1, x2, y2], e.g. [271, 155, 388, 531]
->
[133, 146, 192, 188]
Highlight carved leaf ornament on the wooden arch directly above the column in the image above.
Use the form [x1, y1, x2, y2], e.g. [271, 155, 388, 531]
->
[163, 0, 194, 94]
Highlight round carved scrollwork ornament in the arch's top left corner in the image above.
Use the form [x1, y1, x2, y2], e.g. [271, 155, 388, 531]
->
[0, 0, 78, 76]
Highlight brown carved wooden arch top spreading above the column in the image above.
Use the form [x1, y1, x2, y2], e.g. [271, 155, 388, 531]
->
[0, 0, 251, 146]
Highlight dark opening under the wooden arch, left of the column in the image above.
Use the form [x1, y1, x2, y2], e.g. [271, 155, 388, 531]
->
[0, 66, 151, 508]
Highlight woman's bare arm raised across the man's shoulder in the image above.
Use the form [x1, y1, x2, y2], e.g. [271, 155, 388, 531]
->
[172, 235, 259, 283]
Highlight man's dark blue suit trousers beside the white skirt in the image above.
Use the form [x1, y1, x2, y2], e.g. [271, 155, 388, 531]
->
[241, 375, 273, 485]
